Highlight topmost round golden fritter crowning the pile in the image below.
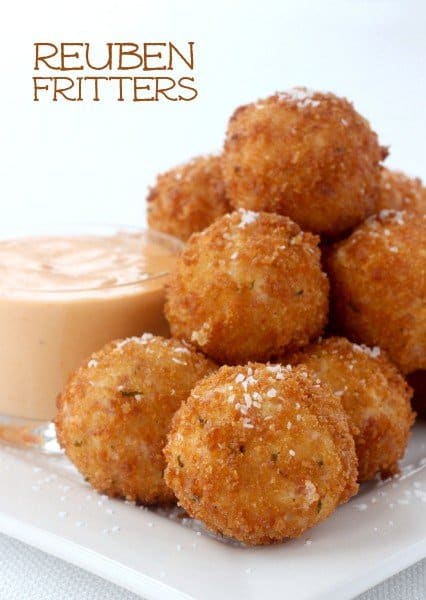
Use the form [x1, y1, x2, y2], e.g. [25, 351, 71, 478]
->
[222, 88, 387, 237]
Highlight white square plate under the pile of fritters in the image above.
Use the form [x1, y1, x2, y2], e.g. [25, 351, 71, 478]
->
[0, 423, 426, 600]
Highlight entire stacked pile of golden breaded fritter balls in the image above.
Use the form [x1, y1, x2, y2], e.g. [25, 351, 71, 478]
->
[57, 88, 426, 544]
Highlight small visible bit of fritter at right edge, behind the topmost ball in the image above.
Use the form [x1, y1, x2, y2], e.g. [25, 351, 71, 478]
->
[377, 167, 426, 214]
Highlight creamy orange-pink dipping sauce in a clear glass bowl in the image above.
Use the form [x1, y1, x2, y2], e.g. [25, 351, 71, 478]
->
[0, 231, 181, 420]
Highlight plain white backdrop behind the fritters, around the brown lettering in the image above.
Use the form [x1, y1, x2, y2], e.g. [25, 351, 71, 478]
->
[0, 0, 426, 230]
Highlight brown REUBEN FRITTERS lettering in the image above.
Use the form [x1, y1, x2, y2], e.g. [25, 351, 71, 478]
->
[33, 41, 198, 102]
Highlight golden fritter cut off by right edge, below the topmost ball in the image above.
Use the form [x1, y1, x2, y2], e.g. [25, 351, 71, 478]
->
[327, 210, 426, 373]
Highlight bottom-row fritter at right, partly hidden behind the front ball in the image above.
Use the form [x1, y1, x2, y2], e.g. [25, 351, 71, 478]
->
[289, 337, 414, 481]
